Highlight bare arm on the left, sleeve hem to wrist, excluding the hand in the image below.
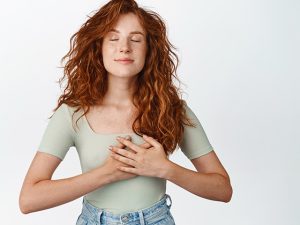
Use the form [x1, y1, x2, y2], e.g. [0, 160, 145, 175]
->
[19, 152, 113, 214]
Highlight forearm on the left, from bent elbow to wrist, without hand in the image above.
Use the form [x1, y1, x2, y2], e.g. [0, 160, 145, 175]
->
[20, 167, 111, 213]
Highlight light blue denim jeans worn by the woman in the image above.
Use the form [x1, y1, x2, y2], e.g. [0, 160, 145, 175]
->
[76, 194, 175, 225]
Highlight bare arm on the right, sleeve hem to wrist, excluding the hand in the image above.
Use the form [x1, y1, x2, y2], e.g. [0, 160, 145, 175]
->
[162, 151, 233, 202]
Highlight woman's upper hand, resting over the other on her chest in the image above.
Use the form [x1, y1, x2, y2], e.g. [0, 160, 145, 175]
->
[110, 135, 170, 178]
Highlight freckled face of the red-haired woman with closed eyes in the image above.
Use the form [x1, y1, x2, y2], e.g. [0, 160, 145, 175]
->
[102, 13, 147, 77]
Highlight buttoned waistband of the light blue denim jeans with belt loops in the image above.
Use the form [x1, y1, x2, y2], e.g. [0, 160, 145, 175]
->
[82, 194, 172, 225]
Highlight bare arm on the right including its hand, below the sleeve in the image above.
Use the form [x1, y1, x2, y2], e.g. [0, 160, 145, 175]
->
[111, 135, 233, 202]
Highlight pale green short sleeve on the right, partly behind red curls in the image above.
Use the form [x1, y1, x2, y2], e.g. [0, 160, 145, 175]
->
[179, 102, 213, 160]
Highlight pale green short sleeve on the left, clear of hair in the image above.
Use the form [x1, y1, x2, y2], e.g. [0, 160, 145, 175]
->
[38, 103, 74, 160]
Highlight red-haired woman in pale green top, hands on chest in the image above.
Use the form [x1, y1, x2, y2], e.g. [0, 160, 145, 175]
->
[20, 0, 232, 225]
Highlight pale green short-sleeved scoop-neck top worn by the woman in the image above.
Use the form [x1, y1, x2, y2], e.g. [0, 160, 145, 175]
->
[38, 101, 213, 213]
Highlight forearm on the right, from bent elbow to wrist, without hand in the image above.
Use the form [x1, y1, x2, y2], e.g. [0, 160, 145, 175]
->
[162, 161, 232, 202]
